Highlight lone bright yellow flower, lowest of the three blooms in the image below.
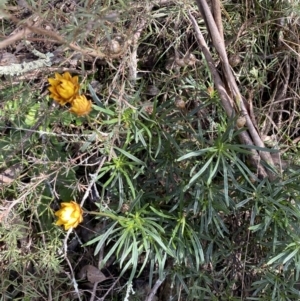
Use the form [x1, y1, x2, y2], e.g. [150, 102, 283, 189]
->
[55, 201, 83, 230]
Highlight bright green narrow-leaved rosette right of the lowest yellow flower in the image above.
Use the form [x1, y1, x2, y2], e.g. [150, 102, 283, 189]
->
[88, 198, 174, 282]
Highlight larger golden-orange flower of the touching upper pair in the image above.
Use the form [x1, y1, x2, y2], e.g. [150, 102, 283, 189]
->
[48, 72, 79, 106]
